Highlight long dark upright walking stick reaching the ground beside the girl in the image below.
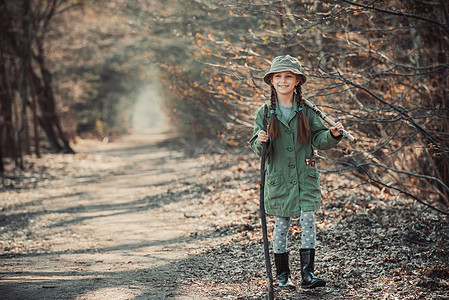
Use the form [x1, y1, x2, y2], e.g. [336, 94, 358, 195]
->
[259, 105, 274, 300]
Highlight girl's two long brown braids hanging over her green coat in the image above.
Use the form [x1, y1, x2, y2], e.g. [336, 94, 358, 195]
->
[268, 77, 310, 144]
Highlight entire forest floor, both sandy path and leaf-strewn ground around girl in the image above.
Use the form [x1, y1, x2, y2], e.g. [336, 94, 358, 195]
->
[0, 132, 449, 300]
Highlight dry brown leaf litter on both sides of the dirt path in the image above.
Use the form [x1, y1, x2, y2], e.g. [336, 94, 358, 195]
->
[0, 135, 449, 299]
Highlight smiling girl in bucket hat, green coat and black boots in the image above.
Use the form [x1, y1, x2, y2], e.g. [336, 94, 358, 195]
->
[250, 55, 343, 288]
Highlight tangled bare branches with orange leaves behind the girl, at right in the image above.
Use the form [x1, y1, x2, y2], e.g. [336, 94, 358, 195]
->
[151, 1, 449, 211]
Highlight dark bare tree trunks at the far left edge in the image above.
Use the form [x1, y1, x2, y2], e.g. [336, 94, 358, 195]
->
[0, 0, 73, 170]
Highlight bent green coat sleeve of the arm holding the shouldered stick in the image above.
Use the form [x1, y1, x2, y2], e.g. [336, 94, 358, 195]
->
[307, 109, 342, 150]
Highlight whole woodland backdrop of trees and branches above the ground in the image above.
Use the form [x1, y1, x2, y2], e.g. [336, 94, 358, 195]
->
[0, 0, 449, 214]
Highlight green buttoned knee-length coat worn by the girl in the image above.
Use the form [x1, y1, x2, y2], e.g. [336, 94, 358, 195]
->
[250, 101, 341, 217]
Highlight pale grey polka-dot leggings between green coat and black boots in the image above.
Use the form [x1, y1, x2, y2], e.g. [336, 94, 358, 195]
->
[273, 211, 316, 254]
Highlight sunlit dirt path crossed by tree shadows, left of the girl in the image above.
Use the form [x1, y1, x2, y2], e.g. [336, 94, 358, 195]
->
[0, 133, 231, 299]
